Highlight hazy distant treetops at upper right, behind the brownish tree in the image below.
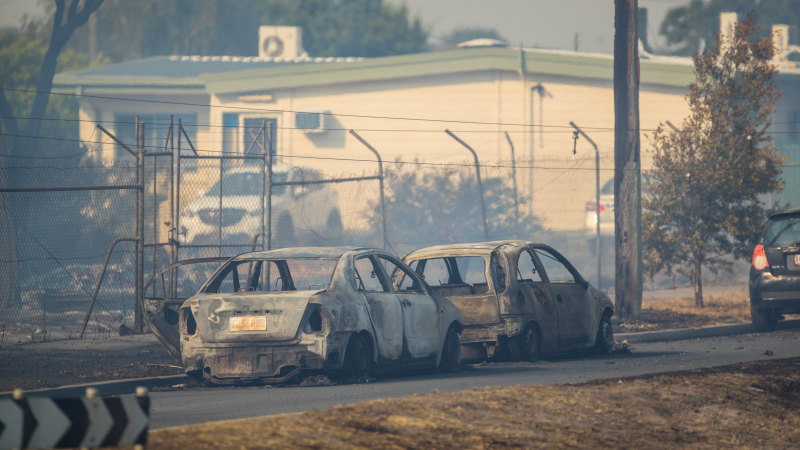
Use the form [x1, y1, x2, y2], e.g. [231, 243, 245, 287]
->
[659, 0, 800, 56]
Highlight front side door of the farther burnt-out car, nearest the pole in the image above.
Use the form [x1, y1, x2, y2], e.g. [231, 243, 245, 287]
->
[532, 244, 596, 350]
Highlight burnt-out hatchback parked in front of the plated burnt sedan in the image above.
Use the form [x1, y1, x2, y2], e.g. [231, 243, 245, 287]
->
[404, 241, 614, 361]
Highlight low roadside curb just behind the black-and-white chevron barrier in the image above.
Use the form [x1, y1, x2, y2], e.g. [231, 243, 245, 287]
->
[0, 375, 191, 398]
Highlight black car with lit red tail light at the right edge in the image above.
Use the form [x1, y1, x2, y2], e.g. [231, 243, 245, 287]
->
[750, 208, 800, 331]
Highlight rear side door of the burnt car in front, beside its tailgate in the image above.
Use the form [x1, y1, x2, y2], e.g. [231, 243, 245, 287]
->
[512, 247, 560, 353]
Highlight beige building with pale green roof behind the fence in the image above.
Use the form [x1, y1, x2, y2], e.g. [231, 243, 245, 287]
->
[55, 30, 792, 236]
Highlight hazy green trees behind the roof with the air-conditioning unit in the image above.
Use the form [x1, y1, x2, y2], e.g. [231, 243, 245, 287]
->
[53, 0, 428, 62]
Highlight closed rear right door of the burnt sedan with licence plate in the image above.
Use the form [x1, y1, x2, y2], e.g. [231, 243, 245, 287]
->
[354, 255, 403, 360]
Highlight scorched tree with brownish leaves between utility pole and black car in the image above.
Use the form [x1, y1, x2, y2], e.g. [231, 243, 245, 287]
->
[642, 15, 784, 306]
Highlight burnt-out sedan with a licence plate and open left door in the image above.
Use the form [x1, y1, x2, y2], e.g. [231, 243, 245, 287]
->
[148, 247, 463, 384]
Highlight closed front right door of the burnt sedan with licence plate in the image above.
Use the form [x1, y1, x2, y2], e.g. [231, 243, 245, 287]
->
[378, 255, 442, 358]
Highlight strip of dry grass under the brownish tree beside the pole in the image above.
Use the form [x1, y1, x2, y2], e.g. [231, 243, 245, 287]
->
[614, 292, 750, 333]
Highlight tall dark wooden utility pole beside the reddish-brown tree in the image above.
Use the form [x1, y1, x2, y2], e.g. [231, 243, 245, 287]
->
[614, 0, 642, 318]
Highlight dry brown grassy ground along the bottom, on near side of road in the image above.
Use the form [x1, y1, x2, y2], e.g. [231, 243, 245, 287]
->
[148, 358, 800, 449]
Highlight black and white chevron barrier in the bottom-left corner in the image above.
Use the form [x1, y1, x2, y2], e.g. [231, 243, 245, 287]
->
[0, 387, 150, 449]
